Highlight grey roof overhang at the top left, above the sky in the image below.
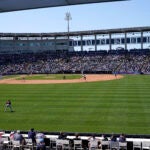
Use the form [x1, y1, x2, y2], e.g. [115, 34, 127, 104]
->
[0, 0, 125, 12]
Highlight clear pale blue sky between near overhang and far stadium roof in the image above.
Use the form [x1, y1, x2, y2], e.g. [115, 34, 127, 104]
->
[0, 0, 150, 33]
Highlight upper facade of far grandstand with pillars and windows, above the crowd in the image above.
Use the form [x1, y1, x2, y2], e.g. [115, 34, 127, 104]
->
[0, 27, 150, 54]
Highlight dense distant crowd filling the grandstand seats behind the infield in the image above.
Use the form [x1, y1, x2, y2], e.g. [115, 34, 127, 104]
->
[0, 50, 150, 75]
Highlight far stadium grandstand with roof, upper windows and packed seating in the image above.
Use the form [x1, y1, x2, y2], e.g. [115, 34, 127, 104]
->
[0, 27, 150, 75]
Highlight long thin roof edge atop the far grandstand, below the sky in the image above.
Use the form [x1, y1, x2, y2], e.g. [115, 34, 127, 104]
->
[0, 26, 150, 37]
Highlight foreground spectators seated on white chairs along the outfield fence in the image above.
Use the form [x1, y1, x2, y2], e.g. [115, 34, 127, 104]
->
[0, 128, 127, 150]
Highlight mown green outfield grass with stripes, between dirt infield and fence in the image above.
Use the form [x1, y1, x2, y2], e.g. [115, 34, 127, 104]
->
[0, 75, 150, 134]
